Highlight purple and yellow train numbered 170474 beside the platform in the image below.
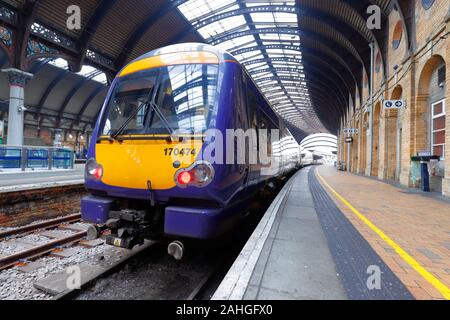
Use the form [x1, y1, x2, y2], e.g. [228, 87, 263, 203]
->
[81, 43, 301, 256]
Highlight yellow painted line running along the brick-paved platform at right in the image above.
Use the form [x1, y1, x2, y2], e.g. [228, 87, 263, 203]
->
[316, 170, 450, 300]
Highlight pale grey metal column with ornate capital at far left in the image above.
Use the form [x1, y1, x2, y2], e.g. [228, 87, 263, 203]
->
[2, 68, 33, 146]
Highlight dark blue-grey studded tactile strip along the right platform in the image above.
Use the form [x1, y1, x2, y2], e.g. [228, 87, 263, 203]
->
[308, 170, 414, 300]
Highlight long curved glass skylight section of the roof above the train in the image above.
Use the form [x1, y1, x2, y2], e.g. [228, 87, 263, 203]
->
[174, 0, 323, 131]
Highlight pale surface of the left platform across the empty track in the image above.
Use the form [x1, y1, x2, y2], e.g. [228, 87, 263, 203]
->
[0, 164, 84, 192]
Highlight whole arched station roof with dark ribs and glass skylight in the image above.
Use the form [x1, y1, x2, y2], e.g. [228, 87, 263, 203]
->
[0, 0, 394, 141]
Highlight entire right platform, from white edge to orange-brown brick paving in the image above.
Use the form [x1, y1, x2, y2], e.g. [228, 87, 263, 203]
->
[213, 166, 450, 300]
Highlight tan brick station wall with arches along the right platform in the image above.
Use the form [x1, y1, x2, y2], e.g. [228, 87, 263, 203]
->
[340, 0, 450, 196]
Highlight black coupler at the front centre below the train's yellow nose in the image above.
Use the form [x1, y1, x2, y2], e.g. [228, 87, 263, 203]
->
[106, 210, 150, 249]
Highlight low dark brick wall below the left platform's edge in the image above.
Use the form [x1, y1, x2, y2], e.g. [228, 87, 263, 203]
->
[0, 184, 86, 227]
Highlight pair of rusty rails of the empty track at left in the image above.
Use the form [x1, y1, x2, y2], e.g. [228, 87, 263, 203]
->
[0, 214, 87, 271]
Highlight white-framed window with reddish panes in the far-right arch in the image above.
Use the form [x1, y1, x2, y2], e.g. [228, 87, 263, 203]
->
[431, 100, 445, 159]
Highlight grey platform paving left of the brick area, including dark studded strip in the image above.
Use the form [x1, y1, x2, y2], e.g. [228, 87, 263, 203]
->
[213, 167, 413, 300]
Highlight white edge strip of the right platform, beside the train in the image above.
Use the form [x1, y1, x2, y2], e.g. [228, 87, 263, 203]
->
[211, 173, 298, 300]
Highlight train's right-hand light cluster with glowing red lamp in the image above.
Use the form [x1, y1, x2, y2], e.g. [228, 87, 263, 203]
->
[175, 161, 214, 188]
